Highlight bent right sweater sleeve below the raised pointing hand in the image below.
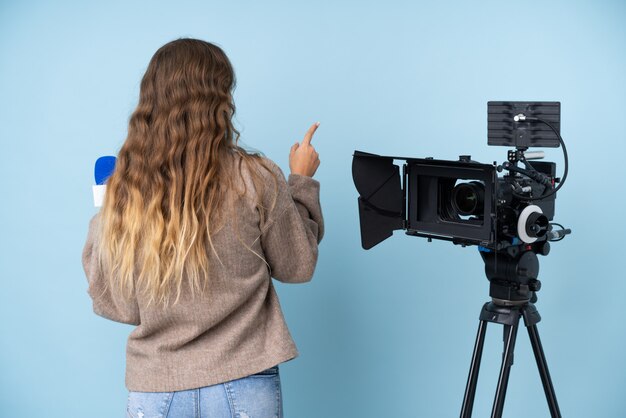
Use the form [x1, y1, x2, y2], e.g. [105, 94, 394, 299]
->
[261, 163, 324, 283]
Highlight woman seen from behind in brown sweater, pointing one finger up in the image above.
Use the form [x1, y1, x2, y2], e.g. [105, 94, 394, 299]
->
[82, 39, 323, 418]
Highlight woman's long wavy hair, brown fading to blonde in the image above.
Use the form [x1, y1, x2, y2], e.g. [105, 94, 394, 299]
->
[99, 39, 269, 305]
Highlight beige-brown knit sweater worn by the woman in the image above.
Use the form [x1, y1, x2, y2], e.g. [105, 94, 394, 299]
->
[82, 160, 323, 392]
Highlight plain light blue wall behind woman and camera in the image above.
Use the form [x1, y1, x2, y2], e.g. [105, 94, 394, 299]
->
[0, 0, 626, 418]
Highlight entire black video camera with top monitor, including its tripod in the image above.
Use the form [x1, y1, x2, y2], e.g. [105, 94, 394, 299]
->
[352, 102, 571, 417]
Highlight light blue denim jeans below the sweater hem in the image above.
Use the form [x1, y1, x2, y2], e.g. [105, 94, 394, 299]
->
[126, 366, 283, 418]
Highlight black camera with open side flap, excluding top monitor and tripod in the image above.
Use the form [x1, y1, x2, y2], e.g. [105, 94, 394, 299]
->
[353, 151, 556, 250]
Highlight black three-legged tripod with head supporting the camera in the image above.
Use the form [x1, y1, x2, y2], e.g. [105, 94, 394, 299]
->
[461, 247, 561, 418]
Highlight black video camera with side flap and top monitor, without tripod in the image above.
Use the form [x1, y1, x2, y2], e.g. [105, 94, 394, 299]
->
[352, 102, 562, 252]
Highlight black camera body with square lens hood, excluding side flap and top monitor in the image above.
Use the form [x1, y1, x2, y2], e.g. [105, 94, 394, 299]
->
[404, 156, 556, 250]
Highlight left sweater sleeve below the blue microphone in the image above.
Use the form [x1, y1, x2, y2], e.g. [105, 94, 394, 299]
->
[82, 213, 140, 325]
